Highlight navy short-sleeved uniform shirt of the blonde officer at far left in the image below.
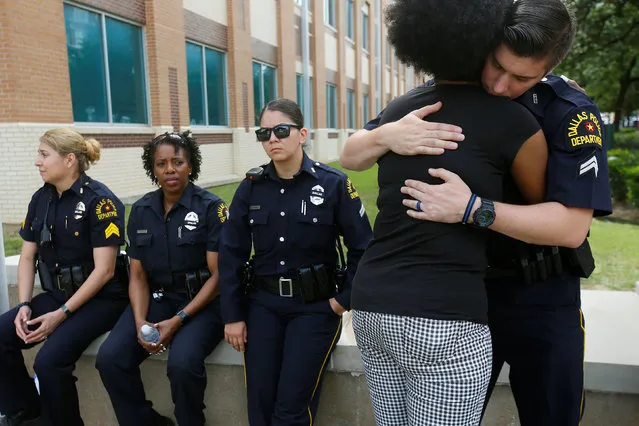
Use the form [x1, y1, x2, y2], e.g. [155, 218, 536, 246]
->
[20, 174, 124, 273]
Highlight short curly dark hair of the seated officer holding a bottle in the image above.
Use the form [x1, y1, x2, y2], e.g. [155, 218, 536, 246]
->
[142, 130, 202, 185]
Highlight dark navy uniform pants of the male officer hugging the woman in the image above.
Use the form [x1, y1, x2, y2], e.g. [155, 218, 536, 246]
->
[486, 306, 585, 426]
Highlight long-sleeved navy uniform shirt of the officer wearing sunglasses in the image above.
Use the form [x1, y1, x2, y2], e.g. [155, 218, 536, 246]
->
[220, 154, 372, 323]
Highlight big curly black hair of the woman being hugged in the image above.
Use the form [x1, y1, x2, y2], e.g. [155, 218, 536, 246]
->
[385, 0, 513, 81]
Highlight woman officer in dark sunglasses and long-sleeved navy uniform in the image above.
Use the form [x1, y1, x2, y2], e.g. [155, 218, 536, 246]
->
[220, 99, 372, 426]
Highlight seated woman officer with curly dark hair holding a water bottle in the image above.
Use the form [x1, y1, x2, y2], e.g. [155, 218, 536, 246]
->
[96, 132, 227, 426]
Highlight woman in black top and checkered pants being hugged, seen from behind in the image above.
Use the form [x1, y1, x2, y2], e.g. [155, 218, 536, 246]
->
[352, 0, 547, 426]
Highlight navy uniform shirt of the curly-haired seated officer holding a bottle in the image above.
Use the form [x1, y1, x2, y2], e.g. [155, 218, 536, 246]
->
[127, 183, 228, 291]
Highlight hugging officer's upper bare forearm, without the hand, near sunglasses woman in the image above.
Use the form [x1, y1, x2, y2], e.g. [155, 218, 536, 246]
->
[339, 126, 388, 171]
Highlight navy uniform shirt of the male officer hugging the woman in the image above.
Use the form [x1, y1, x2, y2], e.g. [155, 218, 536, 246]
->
[487, 74, 612, 307]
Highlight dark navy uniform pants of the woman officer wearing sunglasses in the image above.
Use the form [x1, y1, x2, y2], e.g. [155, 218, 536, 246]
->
[245, 290, 342, 426]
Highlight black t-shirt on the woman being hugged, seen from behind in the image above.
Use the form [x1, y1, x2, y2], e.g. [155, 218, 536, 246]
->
[352, 85, 539, 323]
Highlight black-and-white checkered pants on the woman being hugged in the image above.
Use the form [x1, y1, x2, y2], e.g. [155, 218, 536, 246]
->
[353, 310, 492, 426]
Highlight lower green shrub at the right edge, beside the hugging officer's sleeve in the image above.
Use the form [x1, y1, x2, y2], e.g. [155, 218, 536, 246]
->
[608, 148, 639, 203]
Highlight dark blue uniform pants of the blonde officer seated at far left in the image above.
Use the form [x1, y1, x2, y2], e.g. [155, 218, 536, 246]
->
[0, 291, 126, 426]
